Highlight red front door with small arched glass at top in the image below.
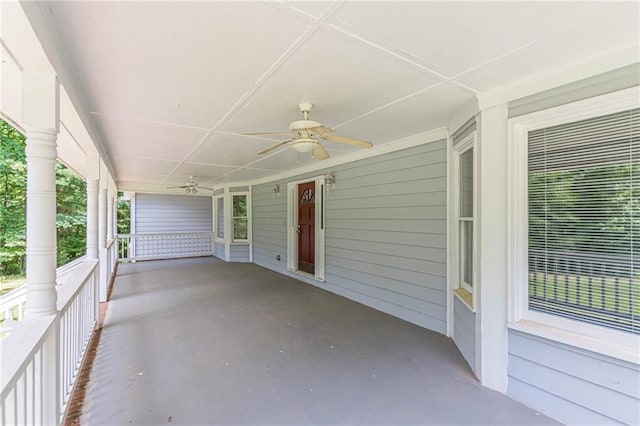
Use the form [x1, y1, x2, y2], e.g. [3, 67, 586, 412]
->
[298, 182, 316, 274]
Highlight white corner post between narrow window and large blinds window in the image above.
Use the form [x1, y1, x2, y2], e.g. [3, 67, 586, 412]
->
[476, 105, 508, 393]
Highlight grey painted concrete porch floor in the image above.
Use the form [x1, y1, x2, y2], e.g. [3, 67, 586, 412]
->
[81, 258, 555, 425]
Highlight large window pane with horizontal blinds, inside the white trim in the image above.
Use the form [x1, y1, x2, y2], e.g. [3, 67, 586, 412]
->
[527, 109, 640, 334]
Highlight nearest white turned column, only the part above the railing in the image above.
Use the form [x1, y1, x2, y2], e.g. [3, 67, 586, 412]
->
[22, 72, 59, 317]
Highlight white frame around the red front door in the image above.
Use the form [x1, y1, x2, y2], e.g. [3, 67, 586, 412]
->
[287, 176, 326, 282]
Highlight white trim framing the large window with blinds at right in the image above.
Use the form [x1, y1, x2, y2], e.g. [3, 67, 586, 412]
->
[507, 87, 640, 364]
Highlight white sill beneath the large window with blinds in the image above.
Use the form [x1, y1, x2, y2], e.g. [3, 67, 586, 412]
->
[509, 312, 640, 364]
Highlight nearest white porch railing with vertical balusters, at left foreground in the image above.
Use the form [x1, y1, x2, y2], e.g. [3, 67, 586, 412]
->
[0, 260, 99, 425]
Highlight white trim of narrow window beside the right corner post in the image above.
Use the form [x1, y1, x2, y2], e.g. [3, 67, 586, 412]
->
[450, 131, 480, 312]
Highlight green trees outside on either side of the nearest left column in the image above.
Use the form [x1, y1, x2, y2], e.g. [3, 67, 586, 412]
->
[0, 120, 87, 276]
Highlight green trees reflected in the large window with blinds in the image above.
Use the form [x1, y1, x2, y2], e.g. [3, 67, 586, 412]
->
[529, 164, 640, 254]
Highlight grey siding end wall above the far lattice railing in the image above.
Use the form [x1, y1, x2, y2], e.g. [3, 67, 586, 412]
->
[135, 194, 213, 234]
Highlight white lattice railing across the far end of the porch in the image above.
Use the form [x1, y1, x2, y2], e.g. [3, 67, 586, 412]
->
[118, 232, 218, 262]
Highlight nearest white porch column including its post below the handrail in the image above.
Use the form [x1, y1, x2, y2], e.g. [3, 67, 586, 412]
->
[22, 72, 60, 424]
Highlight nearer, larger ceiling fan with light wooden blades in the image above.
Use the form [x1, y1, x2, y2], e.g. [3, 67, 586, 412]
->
[243, 102, 373, 160]
